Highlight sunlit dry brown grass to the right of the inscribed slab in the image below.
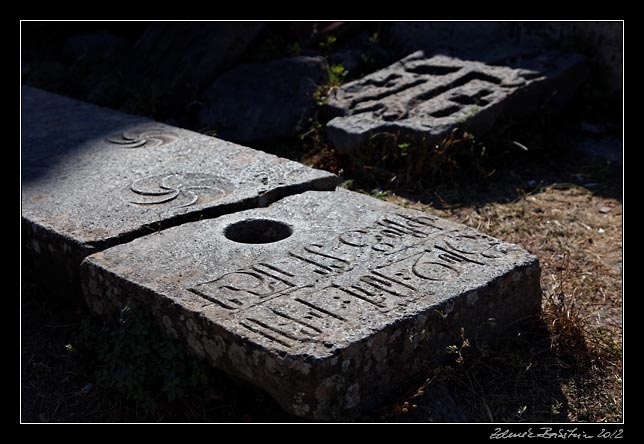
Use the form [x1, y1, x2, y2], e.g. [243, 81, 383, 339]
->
[374, 164, 622, 422]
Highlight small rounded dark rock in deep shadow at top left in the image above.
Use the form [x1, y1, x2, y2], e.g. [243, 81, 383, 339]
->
[63, 32, 129, 62]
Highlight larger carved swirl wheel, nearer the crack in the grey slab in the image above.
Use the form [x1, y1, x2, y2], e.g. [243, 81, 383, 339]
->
[128, 173, 231, 207]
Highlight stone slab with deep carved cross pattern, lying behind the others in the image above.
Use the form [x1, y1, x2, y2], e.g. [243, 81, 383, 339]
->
[326, 50, 585, 154]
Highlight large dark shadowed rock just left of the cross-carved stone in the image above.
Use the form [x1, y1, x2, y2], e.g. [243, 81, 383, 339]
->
[199, 57, 328, 143]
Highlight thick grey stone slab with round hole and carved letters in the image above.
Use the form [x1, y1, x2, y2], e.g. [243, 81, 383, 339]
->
[81, 189, 541, 419]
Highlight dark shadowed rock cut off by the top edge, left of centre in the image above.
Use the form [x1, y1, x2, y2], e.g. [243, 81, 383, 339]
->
[134, 22, 265, 93]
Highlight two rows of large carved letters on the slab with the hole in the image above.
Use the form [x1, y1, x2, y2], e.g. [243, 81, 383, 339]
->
[187, 213, 506, 348]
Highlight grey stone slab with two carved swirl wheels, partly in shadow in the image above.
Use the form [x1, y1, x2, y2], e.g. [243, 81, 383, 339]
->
[21, 87, 336, 293]
